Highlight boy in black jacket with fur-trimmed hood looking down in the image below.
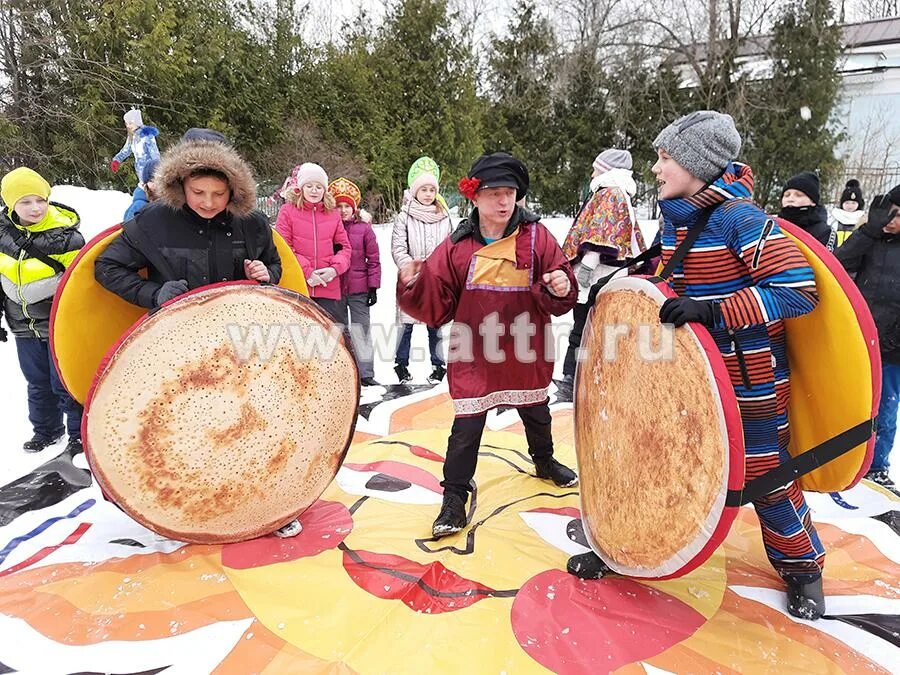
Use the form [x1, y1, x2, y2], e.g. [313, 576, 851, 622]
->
[94, 140, 281, 309]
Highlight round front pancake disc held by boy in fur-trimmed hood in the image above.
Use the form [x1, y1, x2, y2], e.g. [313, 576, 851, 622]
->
[82, 282, 359, 544]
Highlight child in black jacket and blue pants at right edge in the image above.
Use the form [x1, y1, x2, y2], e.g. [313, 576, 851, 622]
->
[835, 185, 900, 488]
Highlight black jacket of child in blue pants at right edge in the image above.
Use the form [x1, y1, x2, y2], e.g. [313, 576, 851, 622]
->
[835, 229, 900, 365]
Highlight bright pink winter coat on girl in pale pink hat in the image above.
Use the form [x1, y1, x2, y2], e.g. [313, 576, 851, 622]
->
[275, 202, 350, 300]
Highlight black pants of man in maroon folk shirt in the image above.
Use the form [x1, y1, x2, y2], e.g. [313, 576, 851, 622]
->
[441, 403, 553, 499]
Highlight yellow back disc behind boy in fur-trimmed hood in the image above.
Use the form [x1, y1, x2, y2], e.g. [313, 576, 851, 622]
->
[50, 225, 308, 404]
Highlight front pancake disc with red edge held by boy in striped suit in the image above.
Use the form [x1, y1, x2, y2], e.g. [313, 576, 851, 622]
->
[575, 278, 743, 578]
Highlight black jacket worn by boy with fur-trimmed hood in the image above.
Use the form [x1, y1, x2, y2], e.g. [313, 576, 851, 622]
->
[94, 202, 281, 308]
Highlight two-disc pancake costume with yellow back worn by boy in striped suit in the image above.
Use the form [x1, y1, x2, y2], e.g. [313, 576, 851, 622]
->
[574, 215, 881, 578]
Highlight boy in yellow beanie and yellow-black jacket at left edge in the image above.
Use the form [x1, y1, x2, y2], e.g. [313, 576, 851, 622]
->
[0, 167, 84, 454]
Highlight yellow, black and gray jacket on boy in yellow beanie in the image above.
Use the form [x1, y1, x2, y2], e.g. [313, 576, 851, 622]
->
[0, 202, 84, 338]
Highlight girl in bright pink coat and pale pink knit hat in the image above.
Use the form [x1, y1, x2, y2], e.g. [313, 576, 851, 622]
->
[275, 162, 350, 324]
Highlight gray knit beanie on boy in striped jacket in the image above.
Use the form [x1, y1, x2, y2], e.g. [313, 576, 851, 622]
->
[653, 110, 741, 183]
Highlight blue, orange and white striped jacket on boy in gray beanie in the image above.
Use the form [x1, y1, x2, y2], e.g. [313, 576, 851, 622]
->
[660, 163, 818, 406]
